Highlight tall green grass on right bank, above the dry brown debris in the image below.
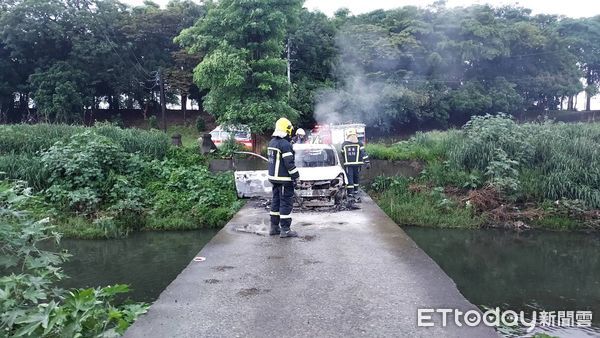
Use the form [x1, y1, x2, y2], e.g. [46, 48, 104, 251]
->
[367, 115, 600, 208]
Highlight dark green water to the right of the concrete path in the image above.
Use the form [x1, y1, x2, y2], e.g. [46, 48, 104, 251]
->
[404, 227, 600, 337]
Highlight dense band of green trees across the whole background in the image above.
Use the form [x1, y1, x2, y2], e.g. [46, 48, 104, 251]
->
[0, 0, 600, 132]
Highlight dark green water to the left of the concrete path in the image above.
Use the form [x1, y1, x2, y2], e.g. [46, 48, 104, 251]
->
[56, 230, 217, 302]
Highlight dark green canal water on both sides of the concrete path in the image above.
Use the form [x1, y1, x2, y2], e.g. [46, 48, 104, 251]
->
[48, 227, 600, 337]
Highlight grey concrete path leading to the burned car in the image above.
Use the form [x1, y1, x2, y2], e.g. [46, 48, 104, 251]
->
[125, 197, 497, 338]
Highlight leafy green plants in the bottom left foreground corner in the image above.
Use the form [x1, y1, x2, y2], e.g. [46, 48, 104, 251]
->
[0, 183, 148, 337]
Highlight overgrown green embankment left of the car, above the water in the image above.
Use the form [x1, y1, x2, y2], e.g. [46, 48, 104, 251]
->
[0, 124, 241, 238]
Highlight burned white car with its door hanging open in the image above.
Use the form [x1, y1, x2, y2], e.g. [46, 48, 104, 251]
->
[234, 144, 348, 207]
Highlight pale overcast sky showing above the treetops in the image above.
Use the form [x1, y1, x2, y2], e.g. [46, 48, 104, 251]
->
[122, 0, 600, 18]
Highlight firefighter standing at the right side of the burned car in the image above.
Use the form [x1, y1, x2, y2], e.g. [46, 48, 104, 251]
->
[342, 128, 371, 203]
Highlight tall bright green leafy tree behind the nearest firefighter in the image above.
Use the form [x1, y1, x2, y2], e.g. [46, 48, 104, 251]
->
[176, 0, 302, 132]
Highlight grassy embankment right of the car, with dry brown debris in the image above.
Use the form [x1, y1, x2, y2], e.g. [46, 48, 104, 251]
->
[367, 116, 600, 230]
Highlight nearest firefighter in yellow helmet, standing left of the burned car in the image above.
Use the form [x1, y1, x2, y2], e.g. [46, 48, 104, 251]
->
[268, 118, 300, 238]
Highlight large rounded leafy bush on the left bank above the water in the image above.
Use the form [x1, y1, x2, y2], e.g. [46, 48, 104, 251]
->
[41, 130, 149, 217]
